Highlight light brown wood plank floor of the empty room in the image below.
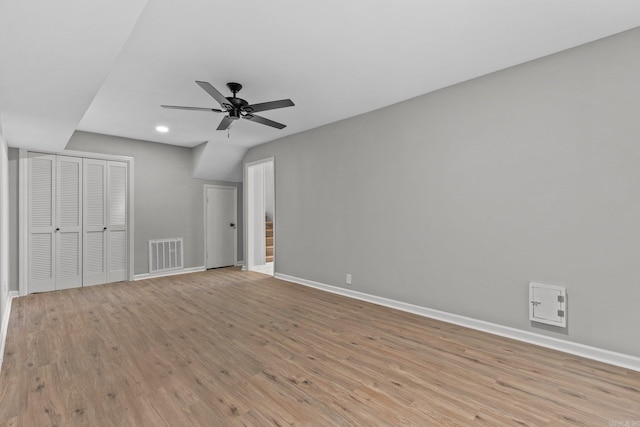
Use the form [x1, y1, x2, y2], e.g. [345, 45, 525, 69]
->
[0, 268, 640, 426]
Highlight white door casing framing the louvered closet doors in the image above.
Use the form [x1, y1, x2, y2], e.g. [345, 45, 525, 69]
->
[18, 148, 135, 296]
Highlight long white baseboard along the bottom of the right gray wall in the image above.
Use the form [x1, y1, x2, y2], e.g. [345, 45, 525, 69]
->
[275, 273, 640, 372]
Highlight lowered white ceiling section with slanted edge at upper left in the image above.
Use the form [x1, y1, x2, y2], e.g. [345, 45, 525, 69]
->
[0, 0, 147, 151]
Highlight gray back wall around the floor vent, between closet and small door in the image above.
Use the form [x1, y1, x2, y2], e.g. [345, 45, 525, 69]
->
[66, 132, 243, 274]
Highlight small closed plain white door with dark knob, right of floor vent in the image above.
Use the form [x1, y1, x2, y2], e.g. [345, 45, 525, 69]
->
[205, 186, 237, 268]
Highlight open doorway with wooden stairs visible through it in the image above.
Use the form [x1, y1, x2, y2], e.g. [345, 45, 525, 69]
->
[245, 158, 276, 276]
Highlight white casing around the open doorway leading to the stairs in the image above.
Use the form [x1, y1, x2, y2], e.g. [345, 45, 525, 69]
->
[242, 156, 278, 274]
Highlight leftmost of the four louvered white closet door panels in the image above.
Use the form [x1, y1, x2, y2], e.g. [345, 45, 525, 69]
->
[27, 153, 56, 293]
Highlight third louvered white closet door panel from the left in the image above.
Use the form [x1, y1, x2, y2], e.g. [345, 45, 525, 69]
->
[83, 159, 107, 286]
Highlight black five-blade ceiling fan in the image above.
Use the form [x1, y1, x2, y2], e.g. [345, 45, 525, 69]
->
[161, 81, 295, 130]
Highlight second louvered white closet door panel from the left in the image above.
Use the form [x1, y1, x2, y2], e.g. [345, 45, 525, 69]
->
[55, 156, 82, 289]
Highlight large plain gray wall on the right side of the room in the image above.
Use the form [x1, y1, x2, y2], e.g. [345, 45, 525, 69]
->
[245, 29, 640, 356]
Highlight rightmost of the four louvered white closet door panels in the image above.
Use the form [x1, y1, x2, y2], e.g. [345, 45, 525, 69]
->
[107, 161, 128, 282]
